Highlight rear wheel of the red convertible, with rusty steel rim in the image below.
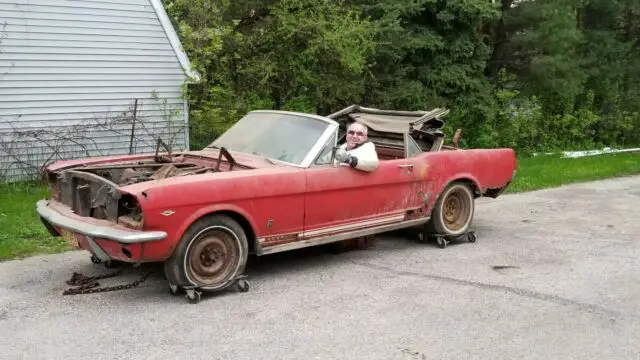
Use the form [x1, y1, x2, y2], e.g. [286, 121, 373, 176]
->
[430, 183, 475, 236]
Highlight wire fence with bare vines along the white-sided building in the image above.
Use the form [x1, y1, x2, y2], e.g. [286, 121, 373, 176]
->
[0, 94, 189, 182]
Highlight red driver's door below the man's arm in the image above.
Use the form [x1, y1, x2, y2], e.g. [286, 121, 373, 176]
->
[304, 150, 417, 238]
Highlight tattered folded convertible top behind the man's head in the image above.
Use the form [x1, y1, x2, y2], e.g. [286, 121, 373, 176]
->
[328, 105, 449, 134]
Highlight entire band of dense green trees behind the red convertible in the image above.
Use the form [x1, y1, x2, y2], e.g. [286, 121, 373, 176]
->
[164, 0, 640, 153]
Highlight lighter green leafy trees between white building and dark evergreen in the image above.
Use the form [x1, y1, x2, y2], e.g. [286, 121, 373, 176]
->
[165, 0, 376, 148]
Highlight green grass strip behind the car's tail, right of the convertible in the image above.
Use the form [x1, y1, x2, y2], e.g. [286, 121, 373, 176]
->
[507, 152, 640, 193]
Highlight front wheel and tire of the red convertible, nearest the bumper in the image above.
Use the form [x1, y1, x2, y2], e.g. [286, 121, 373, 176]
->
[165, 215, 248, 291]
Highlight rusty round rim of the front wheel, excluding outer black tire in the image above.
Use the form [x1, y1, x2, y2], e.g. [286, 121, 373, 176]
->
[187, 229, 240, 286]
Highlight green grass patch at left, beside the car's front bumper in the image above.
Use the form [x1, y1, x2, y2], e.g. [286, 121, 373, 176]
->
[0, 183, 69, 261]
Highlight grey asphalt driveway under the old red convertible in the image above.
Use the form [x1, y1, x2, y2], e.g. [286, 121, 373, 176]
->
[0, 177, 640, 360]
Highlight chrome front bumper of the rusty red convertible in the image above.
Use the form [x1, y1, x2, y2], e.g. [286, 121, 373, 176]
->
[36, 200, 167, 244]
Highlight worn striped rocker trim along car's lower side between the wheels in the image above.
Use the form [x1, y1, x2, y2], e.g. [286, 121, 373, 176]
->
[257, 217, 429, 255]
